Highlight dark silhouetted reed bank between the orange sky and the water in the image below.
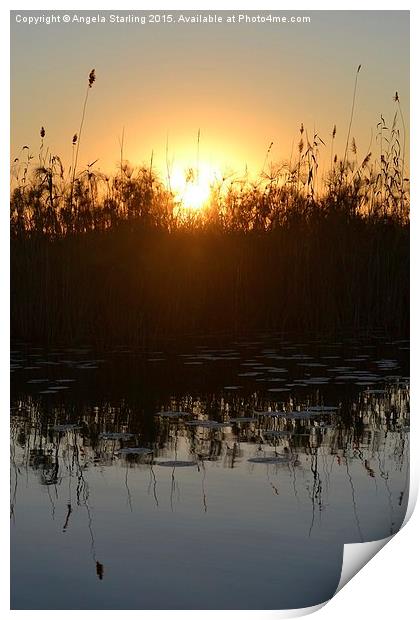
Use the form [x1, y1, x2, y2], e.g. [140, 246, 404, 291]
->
[11, 71, 409, 346]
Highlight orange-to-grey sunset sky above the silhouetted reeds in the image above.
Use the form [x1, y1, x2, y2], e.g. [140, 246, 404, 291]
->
[11, 11, 409, 184]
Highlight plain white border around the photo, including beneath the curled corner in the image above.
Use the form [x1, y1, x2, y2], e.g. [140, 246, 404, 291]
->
[0, 0, 420, 620]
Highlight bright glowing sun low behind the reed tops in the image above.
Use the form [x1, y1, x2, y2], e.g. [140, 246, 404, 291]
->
[169, 162, 221, 211]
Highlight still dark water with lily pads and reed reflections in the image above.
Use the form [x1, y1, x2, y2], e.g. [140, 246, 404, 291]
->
[11, 335, 409, 609]
